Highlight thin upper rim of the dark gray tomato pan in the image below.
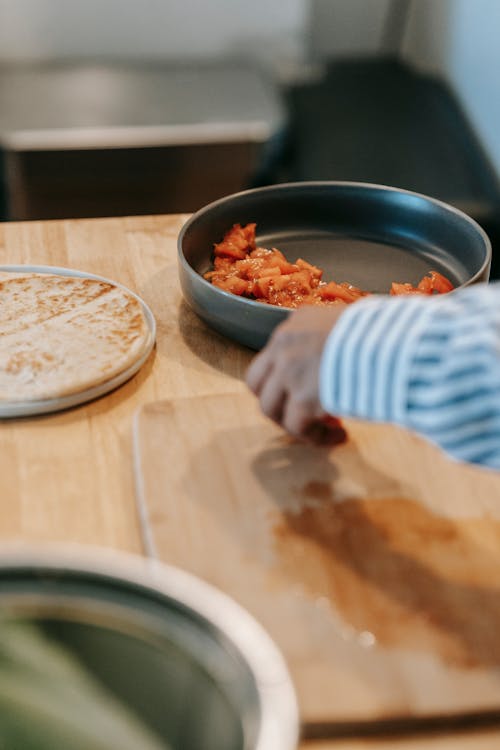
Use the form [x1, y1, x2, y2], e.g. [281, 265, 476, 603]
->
[177, 180, 492, 312]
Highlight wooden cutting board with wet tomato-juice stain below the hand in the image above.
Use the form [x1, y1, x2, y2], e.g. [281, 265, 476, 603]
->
[134, 393, 500, 724]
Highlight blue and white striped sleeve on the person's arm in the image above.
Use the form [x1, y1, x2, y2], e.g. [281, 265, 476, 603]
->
[320, 283, 500, 469]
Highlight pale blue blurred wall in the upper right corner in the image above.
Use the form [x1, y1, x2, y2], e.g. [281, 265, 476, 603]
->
[402, 0, 500, 184]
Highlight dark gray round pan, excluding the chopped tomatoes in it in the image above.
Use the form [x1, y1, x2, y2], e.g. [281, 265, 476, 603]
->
[178, 182, 491, 349]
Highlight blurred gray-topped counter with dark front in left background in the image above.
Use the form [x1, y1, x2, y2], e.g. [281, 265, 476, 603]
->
[0, 63, 285, 220]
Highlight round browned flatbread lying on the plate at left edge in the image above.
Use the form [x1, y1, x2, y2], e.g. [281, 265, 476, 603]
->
[0, 273, 151, 402]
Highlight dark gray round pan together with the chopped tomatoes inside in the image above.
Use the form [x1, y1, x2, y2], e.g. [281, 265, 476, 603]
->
[178, 182, 491, 350]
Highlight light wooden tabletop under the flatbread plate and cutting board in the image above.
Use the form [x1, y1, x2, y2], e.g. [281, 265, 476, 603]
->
[0, 215, 500, 750]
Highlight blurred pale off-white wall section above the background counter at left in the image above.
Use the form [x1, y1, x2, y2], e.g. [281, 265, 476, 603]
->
[0, 0, 307, 70]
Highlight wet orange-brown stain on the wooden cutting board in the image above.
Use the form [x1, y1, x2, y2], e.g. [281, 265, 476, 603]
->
[273, 481, 500, 668]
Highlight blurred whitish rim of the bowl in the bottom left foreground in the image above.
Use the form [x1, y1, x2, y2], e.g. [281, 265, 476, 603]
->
[0, 542, 299, 750]
